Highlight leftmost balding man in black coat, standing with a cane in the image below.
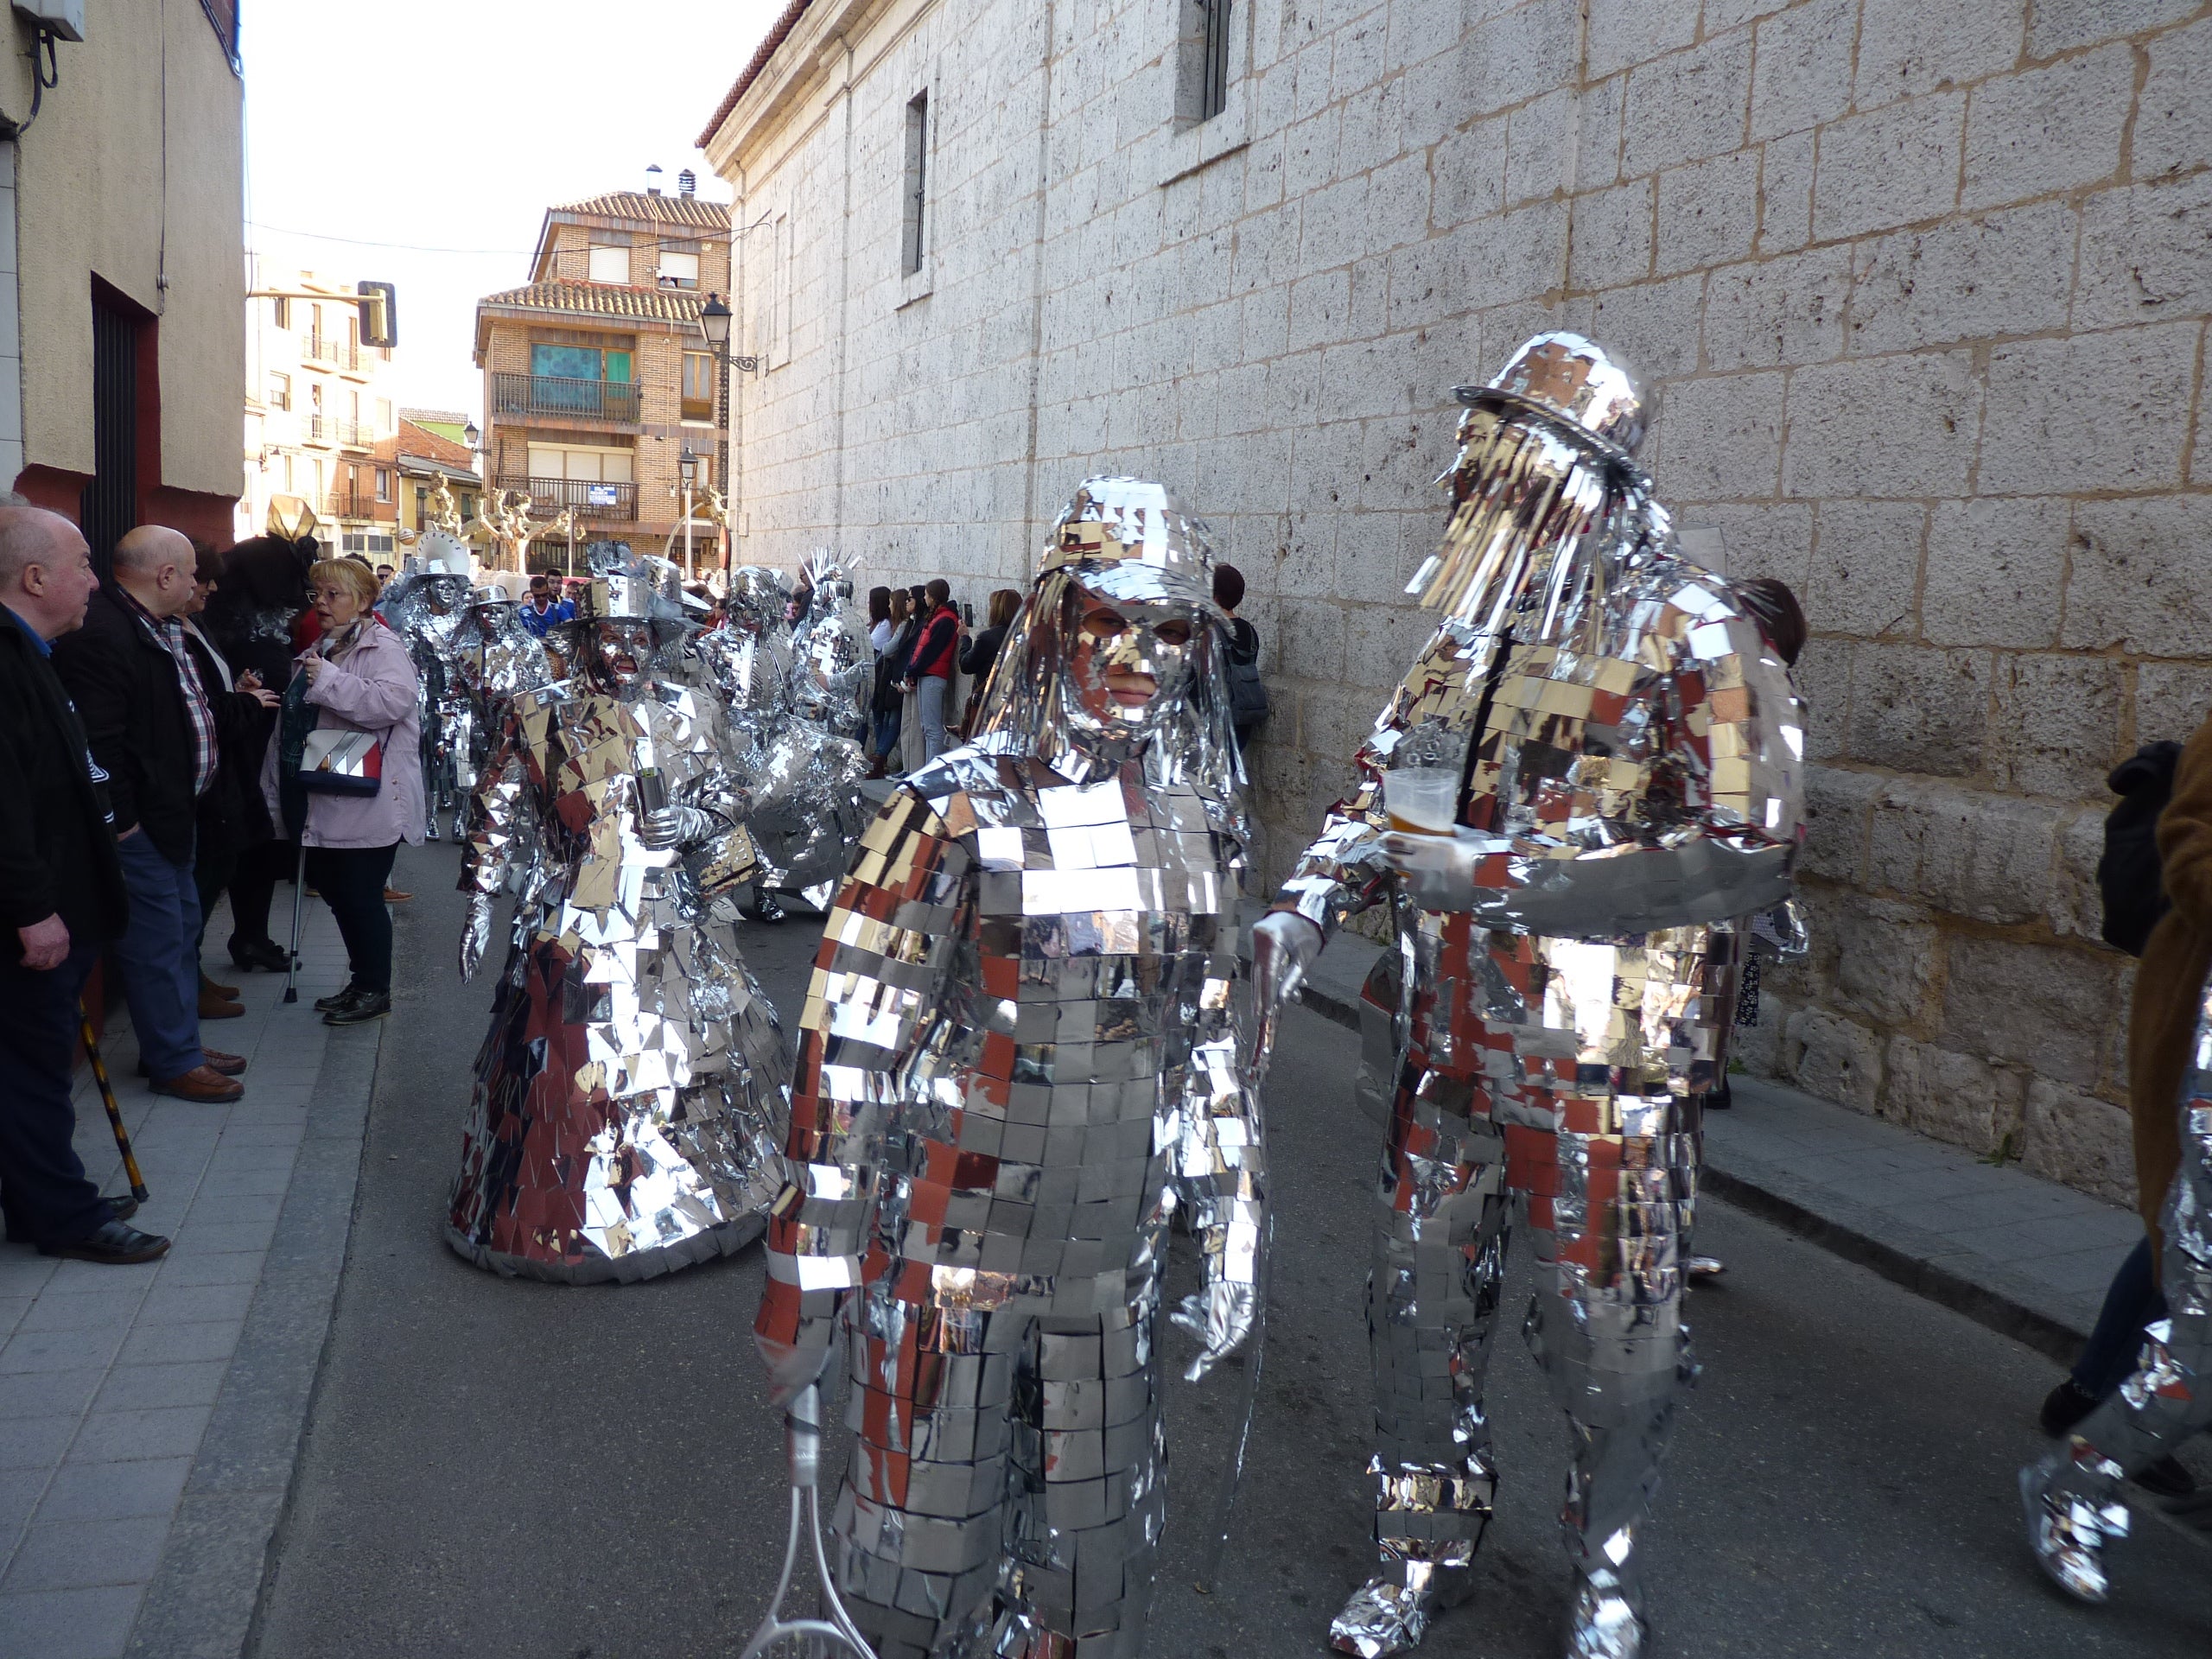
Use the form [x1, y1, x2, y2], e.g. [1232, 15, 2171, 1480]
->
[0, 502, 168, 1261]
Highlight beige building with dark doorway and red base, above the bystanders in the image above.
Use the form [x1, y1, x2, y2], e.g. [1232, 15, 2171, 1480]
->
[0, 0, 245, 564]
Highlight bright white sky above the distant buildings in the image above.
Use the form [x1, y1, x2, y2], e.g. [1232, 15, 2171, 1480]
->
[244, 0, 785, 429]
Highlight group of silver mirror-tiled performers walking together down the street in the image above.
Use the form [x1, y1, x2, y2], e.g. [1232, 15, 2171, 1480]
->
[422, 334, 1822, 1659]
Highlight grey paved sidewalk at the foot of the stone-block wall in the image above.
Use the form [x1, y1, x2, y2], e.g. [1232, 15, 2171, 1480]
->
[1274, 933, 2144, 1365]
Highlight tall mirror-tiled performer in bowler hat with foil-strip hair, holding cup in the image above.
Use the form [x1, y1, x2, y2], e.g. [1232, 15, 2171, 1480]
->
[1256, 334, 1802, 1659]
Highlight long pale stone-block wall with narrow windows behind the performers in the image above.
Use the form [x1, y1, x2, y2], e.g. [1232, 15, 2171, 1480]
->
[703, 0, 2212, 1197]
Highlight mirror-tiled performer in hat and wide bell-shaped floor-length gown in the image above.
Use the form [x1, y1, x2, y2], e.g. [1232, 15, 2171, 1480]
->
[447, 560, 790, 1283]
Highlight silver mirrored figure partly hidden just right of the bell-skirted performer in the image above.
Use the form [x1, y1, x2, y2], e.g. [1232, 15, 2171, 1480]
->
[690, 564, 868, 907]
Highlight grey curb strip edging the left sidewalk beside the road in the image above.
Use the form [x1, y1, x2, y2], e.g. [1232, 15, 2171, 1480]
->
[124, 1024, 383, 1659]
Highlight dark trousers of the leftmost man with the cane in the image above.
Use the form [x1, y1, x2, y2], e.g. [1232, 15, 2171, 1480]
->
[0, 944, 108, 1243]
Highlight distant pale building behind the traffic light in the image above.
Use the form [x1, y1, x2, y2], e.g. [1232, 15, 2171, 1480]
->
[238, 265, 400, 562]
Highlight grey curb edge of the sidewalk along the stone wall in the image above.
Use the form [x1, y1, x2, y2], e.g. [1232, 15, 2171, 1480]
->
[1243, 933, 2094, 1365]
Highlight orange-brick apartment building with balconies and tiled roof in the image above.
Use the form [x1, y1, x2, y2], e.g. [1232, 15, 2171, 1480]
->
[475, 175, 730, 569]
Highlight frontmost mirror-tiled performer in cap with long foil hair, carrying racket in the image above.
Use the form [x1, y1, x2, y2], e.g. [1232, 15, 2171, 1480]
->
[757, 480, 1265, 1659]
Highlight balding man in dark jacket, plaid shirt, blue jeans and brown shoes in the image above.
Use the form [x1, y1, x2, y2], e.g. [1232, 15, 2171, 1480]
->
[53, 524, 245, 1102]
